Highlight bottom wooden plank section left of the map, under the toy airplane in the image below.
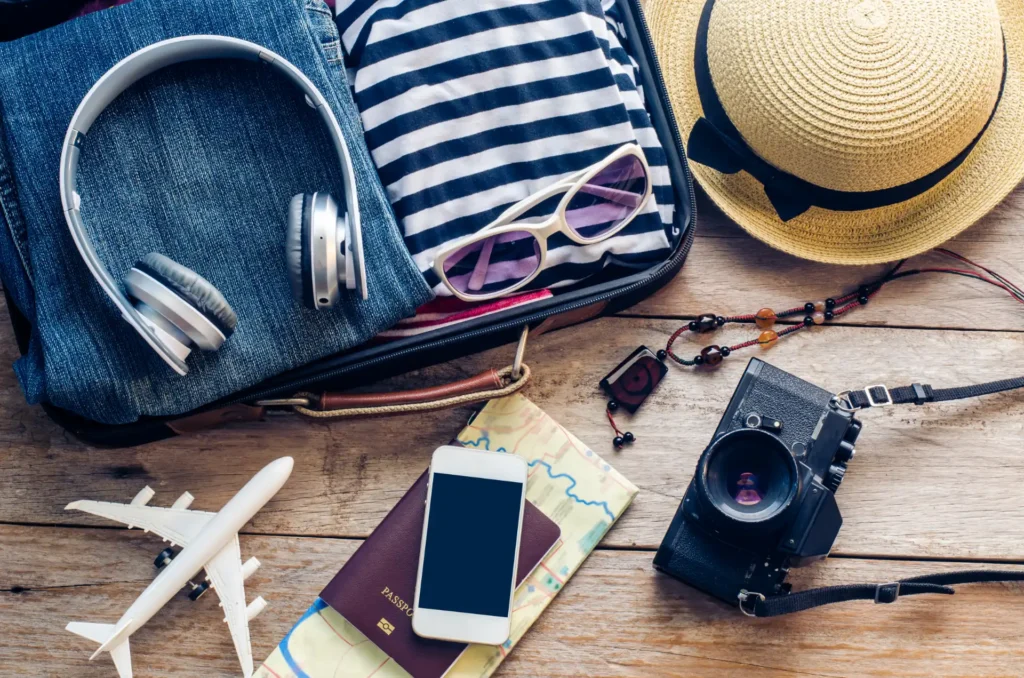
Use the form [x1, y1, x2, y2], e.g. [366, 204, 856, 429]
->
[0, 526, 350, 678]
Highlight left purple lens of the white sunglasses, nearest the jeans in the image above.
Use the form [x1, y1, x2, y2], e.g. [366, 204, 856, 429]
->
[443, 230, 541, 296]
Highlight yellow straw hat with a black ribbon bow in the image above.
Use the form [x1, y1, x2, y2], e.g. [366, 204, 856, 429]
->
[647, 0, 1024, 264]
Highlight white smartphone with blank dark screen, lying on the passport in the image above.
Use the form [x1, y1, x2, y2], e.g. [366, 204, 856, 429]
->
[413, 446, 527, 645]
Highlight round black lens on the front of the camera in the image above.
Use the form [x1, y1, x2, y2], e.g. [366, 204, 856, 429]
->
[700, 429, 799, 524]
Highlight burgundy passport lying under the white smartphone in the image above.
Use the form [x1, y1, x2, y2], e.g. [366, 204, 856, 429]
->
[319, 471, 561, 678]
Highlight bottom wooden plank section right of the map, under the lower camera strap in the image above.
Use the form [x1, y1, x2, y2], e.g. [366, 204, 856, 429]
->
[504, 551, 1024, 678]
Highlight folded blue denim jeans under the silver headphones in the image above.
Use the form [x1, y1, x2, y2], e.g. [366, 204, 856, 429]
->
[0, 0, 430, 423]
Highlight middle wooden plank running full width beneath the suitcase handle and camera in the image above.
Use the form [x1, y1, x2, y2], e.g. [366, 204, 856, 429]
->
[0, 319, 1024, 560]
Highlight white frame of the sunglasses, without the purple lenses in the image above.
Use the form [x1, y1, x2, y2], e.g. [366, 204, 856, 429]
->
[433, 143, 653, 301]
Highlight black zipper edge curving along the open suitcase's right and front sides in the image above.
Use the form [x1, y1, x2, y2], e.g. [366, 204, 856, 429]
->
[225, 0, 697, 408]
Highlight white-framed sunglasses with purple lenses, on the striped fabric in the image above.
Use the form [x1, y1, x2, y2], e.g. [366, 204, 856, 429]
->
[433, 143, 651, 301]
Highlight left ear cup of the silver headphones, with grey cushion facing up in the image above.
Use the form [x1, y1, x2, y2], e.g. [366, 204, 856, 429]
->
[125, 252, 238, 350]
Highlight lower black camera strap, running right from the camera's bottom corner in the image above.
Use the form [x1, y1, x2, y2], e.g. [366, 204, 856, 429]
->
[739, 569, 1024, 617]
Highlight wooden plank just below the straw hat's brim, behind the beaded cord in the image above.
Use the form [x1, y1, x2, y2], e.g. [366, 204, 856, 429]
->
[629, 188, 1024, 331]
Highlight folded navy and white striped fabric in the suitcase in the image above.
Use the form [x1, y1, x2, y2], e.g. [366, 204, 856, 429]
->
[337, 0, 674, 295]
